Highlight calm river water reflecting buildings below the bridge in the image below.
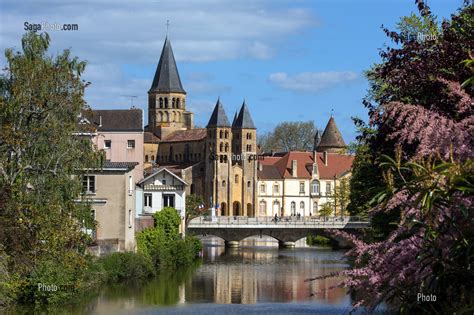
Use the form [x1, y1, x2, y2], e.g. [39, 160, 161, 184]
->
[10, 238, 378, 315]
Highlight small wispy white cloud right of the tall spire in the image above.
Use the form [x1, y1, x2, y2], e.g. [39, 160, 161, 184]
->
[269, 71, 359, 92]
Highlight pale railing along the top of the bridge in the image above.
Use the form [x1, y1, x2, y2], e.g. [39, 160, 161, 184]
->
[190, 216, 369, 226]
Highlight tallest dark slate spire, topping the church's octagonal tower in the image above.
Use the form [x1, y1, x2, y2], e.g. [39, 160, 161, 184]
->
[149, 37, 186, 94]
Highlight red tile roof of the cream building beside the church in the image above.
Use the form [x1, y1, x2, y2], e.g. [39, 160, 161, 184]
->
[258, 151, 354, 179]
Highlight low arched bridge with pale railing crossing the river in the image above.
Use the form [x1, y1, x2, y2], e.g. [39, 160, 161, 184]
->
[187, 216, 369, 247]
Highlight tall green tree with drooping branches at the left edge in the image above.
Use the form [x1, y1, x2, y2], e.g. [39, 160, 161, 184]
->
[0, 32, 99, 304]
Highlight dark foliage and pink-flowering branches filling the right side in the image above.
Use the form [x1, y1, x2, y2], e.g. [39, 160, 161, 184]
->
[312, 0, 474, 314]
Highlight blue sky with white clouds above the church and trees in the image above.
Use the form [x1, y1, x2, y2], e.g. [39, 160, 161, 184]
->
[0, 0, 462, 143]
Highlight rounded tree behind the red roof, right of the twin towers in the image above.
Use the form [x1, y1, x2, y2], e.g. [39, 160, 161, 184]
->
[258, 121, 317, 152]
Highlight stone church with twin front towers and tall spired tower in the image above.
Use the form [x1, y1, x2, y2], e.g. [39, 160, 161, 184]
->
[144, 38, 257, 216]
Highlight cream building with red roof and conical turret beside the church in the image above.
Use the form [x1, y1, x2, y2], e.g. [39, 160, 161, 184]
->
[257, 117, 354, 216]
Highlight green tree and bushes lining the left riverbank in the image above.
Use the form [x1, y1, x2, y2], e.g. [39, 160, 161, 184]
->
[0, 32, 201, 308]
